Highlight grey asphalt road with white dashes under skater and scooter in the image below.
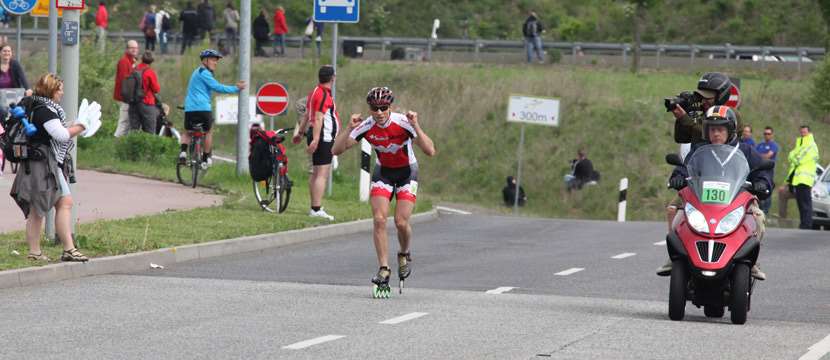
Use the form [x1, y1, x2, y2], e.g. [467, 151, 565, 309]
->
[0, 215, 830, 360]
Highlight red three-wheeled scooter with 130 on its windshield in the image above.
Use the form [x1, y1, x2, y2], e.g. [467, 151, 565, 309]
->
[666, 145, 773, 324]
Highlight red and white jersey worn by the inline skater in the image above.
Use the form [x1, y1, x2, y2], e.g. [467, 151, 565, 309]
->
[349, 112, 418, 168]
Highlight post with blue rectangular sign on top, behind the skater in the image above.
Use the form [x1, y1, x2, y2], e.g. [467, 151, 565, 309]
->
[313, 0, 360, 196]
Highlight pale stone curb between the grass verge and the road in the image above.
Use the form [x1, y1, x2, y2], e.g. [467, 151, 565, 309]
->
[0, 209, 439, 289]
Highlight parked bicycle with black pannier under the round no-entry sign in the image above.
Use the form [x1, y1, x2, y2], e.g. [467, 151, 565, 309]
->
[251, 127, 293, 214]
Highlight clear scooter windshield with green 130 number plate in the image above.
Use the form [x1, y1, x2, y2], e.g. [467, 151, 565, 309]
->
[686, 145, 749, 205]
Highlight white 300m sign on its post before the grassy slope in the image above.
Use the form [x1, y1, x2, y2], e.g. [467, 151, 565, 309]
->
[507, 95, 559, 214]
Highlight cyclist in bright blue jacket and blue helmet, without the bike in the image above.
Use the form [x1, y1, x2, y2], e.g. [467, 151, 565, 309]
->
[179, 49, 246, 166]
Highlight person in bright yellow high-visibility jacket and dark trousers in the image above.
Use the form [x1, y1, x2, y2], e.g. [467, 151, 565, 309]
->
[778, 125, 819, 229]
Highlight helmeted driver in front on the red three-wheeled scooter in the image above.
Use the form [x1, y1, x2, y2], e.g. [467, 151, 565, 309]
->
[657, 106, 772, 280]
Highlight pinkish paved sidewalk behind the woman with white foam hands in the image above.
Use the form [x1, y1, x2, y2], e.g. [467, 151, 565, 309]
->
[0, 167, 222, 233]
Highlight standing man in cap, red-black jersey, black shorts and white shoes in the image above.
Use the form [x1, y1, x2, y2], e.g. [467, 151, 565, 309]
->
[291, 65, 340, 221]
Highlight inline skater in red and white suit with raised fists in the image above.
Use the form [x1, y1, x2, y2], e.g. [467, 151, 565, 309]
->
[332, 87, 435, 298]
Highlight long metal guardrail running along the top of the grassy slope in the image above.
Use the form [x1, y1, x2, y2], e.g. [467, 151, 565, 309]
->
[0, 28, 826, 62]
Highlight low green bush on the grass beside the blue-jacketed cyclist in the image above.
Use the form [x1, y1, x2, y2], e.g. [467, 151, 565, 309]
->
[115, 132, 178, 164]
